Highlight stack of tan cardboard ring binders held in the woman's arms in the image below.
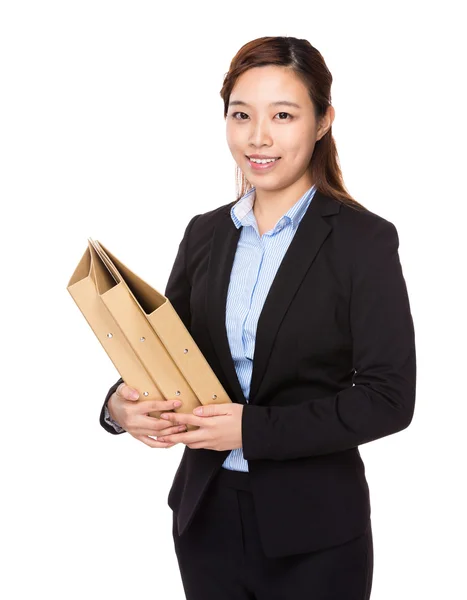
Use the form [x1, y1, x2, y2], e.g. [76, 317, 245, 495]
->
[67, 238, 231, 430]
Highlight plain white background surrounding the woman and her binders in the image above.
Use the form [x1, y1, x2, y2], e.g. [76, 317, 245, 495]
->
[0, 0, 467, 600]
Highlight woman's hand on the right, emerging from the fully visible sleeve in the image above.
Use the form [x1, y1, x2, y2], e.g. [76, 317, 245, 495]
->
[157, 402, 243, 451]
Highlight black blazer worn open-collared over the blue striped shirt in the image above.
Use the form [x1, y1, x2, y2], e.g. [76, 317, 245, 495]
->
[100, 191, 416, 557]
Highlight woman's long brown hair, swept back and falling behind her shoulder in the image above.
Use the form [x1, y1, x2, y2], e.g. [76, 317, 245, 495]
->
[220, 36, 366, 210]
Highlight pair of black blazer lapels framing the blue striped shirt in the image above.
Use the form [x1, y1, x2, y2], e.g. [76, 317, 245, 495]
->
[206, 191, 340, 404]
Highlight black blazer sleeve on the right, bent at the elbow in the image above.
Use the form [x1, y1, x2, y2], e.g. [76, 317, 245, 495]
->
[242, 219, 416, 460]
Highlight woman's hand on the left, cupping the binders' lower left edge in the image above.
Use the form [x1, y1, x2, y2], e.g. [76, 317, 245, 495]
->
[107, 382, 186, 448]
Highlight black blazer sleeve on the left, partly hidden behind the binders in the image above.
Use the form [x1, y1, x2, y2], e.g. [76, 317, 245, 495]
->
[99, 215, 200, 434]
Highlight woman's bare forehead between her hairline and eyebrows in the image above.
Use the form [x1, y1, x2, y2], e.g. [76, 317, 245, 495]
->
[229, 65, 310, 107]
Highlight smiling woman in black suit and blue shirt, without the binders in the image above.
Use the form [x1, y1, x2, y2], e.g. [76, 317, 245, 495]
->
[101, 37, 416, 600]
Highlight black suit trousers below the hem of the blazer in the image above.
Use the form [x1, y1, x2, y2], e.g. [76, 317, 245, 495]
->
[173, 468, 373, 600]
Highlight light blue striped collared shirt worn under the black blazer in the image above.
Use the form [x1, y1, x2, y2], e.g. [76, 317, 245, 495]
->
[222, 186, 316, 471]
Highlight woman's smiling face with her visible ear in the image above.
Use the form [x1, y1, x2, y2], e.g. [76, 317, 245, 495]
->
[226, 65, 334, 197]
